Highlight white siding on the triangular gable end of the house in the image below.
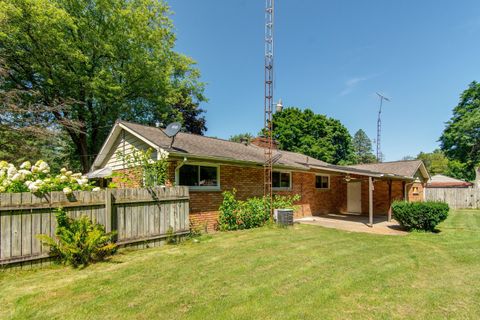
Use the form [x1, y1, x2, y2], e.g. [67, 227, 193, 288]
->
[101, 130, 157, 170]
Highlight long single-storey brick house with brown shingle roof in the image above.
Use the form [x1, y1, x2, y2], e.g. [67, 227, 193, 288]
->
[91, 121, 428, 230]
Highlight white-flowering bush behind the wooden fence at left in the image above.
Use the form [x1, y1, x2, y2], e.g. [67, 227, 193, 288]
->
[0, 160, 95, 194]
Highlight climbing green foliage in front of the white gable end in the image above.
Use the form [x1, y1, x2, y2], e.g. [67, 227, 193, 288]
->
[117, 148, 169, 188]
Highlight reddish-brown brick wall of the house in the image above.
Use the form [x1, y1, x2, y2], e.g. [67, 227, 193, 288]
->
[114, 161, 423, 231]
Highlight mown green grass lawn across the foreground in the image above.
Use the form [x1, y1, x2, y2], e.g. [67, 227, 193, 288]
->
[0, 210, 480, 319]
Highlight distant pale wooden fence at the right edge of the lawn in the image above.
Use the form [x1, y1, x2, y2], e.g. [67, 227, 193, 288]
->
[425, 188, 480, 209]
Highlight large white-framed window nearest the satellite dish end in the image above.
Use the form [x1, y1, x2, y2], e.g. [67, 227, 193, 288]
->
[178, 164, 219, 188]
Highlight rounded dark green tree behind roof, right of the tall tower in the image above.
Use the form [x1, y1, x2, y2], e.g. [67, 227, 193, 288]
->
[273, 107, 355, 164]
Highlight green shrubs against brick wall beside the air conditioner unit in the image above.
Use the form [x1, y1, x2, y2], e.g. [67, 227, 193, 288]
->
[218, 189, 300, 231]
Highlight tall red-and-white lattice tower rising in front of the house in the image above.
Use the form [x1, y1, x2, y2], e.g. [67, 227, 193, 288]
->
[263, 0, 274, 214]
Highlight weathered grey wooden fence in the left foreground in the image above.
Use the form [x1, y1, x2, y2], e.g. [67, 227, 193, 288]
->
[0, 187, 190, 265]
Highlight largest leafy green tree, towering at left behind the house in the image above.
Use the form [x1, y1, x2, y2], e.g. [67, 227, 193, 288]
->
[0, 0, 206, 171]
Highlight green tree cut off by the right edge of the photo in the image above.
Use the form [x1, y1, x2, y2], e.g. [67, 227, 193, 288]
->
[440, 81, 480, 180]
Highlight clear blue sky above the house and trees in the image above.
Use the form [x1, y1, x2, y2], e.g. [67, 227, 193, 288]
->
[167, 0, 480, 161]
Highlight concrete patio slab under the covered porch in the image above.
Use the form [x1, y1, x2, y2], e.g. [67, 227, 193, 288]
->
[295, 213, 408, 235]
